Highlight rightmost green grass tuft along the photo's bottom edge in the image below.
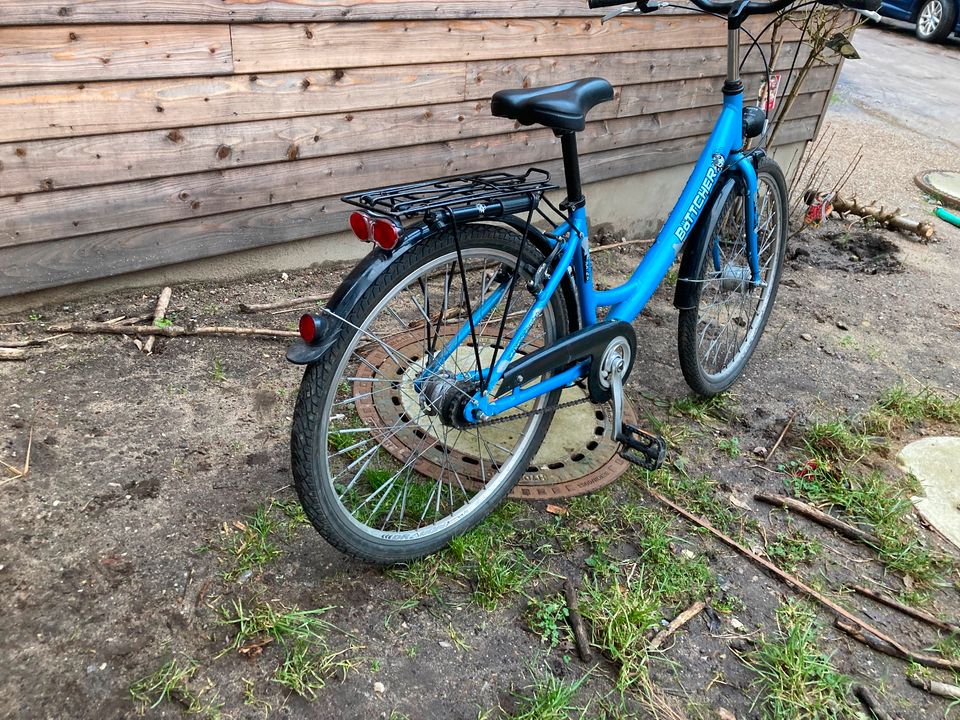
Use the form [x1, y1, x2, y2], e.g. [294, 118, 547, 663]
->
[741, 602, 859, 720]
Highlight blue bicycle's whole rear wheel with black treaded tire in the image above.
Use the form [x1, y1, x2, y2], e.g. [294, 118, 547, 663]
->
[291, 225, 568, 564]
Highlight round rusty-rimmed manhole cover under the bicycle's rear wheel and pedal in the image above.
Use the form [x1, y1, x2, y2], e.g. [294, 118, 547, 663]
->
[354, 331, 636, 500]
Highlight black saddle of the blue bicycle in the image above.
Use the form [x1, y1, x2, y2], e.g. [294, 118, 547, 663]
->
[490, 78, 613, 130]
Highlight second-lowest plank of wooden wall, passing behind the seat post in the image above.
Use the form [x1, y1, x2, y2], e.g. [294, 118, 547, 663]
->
[0, 96, 824, 247]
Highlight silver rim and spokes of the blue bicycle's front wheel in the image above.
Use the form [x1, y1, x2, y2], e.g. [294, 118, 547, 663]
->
[697, 174, 784, 383]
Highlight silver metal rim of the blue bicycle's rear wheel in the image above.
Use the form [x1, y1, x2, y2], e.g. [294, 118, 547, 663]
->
[318, 248, 554, 542]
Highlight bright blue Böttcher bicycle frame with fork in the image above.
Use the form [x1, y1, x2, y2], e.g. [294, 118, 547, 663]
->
[426, 38, 760, 422]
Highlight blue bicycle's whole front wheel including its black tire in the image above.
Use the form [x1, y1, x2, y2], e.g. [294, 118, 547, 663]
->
[677, 157, 789, 397]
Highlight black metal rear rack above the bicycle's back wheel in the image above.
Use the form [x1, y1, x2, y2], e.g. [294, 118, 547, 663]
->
[341, 168, 558, 220]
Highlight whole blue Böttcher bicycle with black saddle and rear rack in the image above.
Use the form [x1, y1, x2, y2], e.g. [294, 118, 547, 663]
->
[287, 0, 879, 563]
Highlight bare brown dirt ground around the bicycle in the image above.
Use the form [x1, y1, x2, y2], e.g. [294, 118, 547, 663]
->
[0, 25, 960, 720]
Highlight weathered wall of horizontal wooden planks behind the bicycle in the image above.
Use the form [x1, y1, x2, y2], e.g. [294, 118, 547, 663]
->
[0, 0, 837, 296]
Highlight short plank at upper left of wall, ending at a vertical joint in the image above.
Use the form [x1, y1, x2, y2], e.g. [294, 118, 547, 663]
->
[0, 25, 233, 86]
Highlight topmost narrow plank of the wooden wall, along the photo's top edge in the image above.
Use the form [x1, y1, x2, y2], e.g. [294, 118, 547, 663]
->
[0, 0, 606, 25]
